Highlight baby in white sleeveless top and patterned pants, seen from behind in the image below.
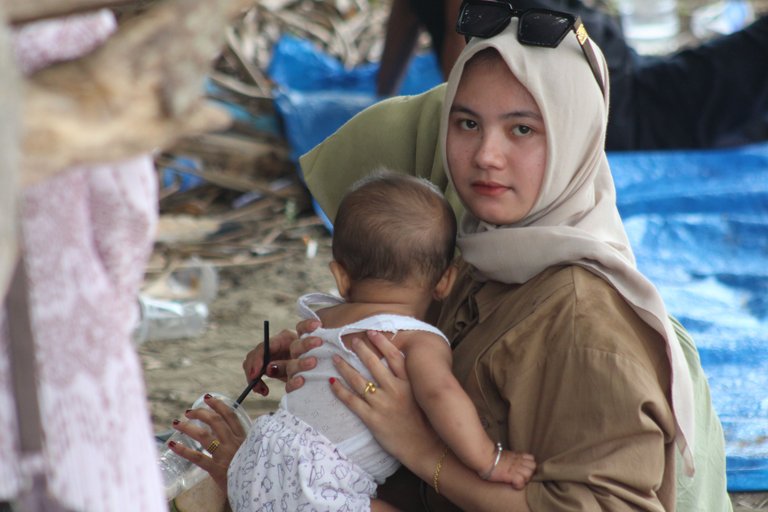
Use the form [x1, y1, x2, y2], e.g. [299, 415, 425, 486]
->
[227, 172, 535, 512]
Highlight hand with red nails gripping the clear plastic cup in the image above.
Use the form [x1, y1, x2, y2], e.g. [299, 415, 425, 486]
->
[168, 395, 246, 493]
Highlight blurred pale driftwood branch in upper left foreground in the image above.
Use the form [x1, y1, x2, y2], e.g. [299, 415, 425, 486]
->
[22, 0, 249, 183]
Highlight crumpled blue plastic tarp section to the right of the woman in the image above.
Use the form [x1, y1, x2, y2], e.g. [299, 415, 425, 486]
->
[609, 144, 768, 491]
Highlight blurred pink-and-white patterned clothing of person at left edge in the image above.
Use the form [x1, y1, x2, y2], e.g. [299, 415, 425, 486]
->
[0, 13, 167, 512]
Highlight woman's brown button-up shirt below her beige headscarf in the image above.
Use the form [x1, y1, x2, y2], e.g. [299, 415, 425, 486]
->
[428, 264, 675, 511]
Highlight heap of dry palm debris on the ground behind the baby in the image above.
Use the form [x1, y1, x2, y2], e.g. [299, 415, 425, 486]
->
[148, 0, 408, 273]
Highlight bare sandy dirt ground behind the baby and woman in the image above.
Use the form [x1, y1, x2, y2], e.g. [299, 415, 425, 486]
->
[139, 217, 768, 512]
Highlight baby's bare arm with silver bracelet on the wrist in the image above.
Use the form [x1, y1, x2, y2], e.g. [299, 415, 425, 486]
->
[399, 332, 536, 489]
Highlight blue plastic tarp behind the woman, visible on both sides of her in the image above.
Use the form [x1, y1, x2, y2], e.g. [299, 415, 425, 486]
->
[269, 37, 768, 491]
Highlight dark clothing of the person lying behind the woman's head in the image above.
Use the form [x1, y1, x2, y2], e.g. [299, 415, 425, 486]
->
[410, 0, 768, 151]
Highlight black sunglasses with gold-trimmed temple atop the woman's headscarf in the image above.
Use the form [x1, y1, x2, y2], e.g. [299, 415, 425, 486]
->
[456, 0, 605, 94]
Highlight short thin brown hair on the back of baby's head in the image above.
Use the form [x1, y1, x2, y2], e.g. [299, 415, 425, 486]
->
[333, 170, 456, 287]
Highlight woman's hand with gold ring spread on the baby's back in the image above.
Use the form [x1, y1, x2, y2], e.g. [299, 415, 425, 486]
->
[331, 331, 441, 464]
